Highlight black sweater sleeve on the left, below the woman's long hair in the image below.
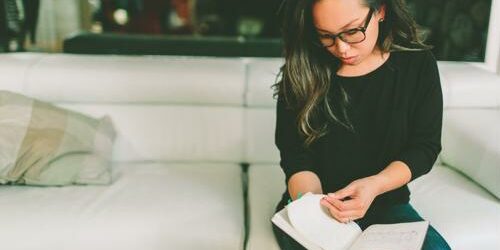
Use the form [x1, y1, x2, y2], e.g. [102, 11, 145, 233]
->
[275, 97, 313, 184]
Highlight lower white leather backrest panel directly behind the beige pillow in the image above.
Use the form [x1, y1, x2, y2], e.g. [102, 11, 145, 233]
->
[57, 104, 244, 163]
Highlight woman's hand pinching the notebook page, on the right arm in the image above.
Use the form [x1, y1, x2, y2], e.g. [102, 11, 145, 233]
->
[321, 176, 380, 223]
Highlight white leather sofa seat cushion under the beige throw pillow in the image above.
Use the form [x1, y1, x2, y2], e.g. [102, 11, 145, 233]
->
[0, 163, 244, 250]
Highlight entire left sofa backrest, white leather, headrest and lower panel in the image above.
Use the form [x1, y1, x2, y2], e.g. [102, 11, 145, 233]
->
[0, 53, 245, 163]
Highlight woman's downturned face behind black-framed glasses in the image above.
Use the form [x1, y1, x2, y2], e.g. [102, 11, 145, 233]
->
[312, 0, 385, 65]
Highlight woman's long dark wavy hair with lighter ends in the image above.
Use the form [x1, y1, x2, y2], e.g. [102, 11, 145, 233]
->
[272, 0, 430, 147]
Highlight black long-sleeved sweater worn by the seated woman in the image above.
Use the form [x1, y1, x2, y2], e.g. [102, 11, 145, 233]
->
[275, 51, 443, 210]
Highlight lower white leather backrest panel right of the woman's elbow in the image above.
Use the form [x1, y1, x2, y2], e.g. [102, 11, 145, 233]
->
[441, 109, 500, 198]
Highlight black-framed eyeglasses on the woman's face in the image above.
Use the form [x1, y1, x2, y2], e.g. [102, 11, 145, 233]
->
[318, 8, 374, 48]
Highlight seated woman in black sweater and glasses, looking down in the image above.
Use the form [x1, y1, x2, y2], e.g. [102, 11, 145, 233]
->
[273, 0, 450, 249]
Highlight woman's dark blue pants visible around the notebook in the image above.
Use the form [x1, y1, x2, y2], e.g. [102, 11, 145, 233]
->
[272, 204, 451, 250]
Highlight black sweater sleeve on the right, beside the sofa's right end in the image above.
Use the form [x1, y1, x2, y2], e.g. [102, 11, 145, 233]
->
[395, 51, 443, 182]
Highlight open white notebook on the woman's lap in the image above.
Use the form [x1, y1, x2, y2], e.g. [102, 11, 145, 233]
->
[271, 193, 429, 250]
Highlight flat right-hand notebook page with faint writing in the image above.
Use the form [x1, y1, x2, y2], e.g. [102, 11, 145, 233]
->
[350, 221, 429, 250]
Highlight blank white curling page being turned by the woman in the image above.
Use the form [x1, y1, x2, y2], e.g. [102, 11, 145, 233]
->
[287, 193, 361, 250]
